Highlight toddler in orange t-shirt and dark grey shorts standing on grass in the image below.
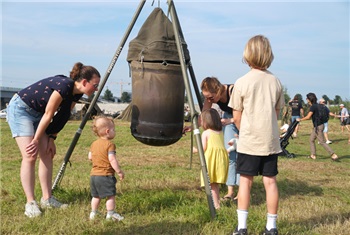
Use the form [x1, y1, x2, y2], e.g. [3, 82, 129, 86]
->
[89, 116, 124, 221]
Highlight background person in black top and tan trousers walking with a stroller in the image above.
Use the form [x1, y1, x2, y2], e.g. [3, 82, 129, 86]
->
[297, 93, 338, 161]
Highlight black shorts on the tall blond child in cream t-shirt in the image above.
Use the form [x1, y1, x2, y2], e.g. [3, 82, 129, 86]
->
[237, 153, 278, 176]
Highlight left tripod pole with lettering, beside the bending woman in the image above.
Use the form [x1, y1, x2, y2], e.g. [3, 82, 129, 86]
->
[52, 0, 146, 190]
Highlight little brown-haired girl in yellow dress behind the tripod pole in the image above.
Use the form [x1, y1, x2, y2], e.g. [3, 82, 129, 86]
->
[201, 108, 229, 209]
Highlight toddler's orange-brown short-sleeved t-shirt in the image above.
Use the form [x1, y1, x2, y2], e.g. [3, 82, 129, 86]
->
[90, 139, 116, 175]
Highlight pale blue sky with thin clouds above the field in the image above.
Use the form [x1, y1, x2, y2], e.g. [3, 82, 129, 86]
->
[0, 0, 350, 101]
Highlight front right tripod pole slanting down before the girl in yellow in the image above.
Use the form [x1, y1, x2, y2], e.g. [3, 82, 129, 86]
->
[168, 0, 216, 219]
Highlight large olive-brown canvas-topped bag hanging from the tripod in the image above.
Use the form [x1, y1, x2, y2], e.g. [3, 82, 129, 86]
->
[127, 8, 189, 146]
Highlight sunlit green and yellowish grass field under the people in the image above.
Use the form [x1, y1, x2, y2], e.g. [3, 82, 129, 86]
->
[0, 119, 350, 235]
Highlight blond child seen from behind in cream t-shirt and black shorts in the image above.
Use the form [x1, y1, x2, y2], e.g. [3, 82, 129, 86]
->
[228, 35, 285, 235]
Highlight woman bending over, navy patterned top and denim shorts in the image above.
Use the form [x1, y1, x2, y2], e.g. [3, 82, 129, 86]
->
[7, 62, 100, 218]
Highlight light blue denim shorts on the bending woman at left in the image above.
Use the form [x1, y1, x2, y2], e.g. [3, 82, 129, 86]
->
[7, 94, 43, 138]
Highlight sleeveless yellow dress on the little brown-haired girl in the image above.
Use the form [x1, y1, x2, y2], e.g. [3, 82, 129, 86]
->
[201, 131, 229, 187]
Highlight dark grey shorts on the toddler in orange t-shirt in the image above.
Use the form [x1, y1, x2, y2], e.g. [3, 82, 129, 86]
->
[90, 175, 117, 198]
